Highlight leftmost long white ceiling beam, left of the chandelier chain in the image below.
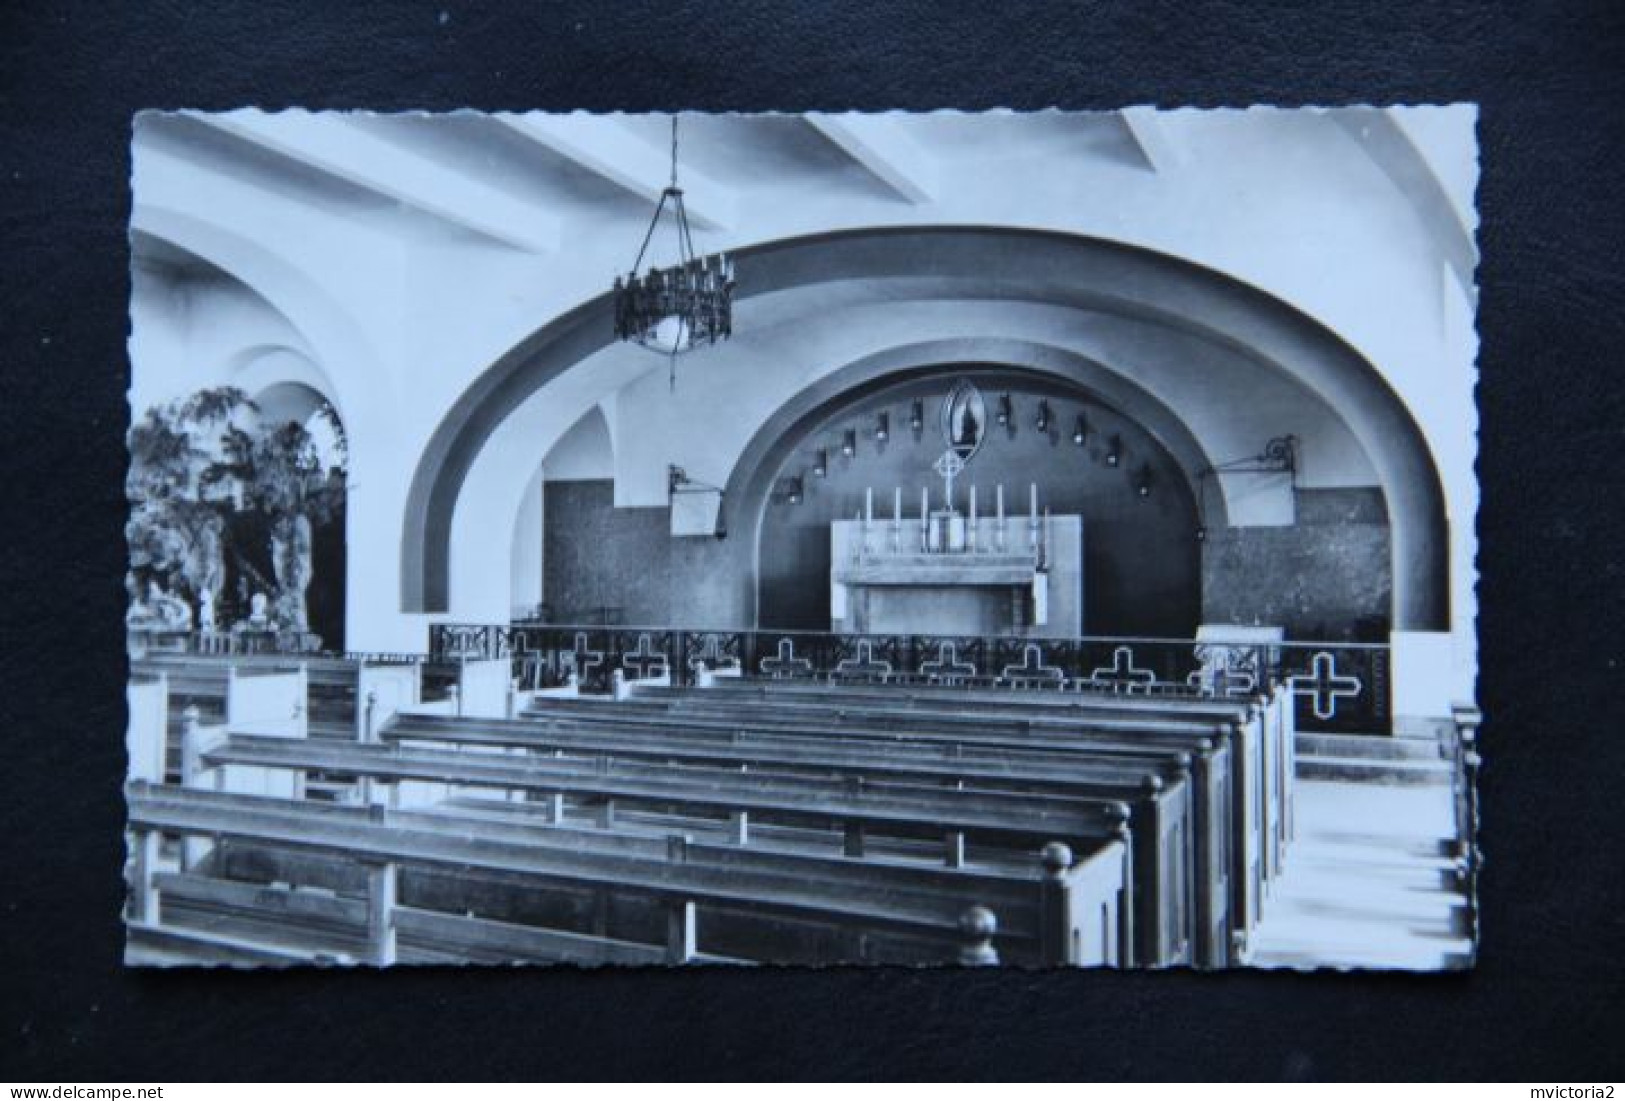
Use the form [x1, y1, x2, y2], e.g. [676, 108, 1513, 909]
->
[197, 110, 559, 252]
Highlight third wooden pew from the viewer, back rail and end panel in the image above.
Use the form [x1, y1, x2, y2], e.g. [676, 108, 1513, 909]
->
[382, 716, 1196, 963]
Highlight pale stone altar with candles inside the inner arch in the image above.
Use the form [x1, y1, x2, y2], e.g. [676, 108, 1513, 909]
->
[830, 489, 1084, 638]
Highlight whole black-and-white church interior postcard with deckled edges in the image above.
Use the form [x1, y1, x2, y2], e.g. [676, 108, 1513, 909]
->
[124, 106, 1480, 971]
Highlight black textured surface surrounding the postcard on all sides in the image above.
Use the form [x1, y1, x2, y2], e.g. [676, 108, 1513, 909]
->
[0, 0, 1625, 1083]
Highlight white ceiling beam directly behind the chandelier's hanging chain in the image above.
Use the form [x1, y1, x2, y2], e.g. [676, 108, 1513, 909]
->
[496, 112, 738, 229]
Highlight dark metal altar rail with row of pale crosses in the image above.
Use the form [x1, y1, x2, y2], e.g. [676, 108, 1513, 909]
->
[429, 624, 1391, 734]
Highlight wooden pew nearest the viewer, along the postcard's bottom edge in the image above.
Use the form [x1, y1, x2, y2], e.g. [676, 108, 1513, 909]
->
[128, 783, 1125, 963]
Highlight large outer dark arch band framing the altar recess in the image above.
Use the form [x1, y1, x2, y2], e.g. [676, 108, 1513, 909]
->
[401, 227, 1450, 630]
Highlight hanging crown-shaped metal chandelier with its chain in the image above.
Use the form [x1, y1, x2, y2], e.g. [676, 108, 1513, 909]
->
[614, 115, 733, 386]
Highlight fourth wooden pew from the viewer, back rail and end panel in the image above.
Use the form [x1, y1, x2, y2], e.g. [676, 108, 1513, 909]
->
[527, 690, 1235, 966]
